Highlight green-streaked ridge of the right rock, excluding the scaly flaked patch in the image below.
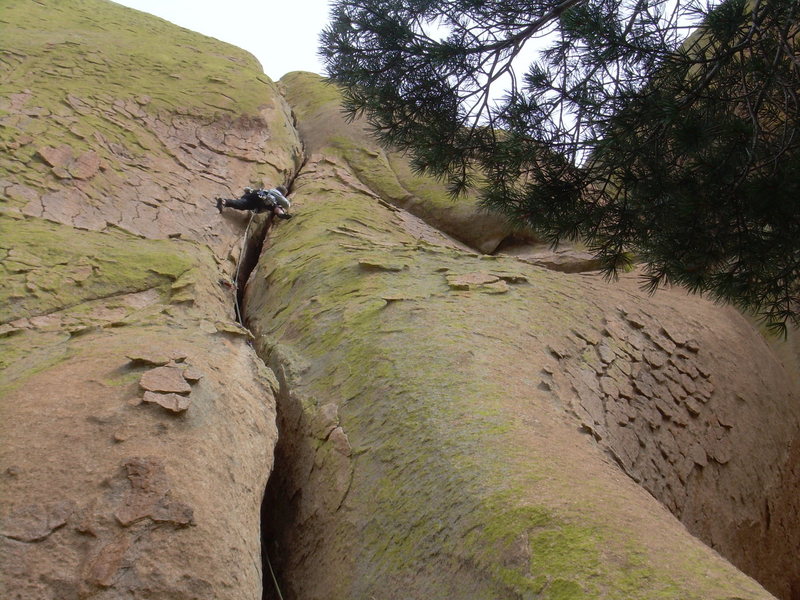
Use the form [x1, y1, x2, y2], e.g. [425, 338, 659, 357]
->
[246, 146, 769, 600]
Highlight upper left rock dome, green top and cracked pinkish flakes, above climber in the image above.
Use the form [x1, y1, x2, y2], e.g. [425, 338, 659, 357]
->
[0, 0, 301, 227]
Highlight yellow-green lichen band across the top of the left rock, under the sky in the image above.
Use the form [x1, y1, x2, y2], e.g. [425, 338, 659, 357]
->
[0, 0, 269, 118]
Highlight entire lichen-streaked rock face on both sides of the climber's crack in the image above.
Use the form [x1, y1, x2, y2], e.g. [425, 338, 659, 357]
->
[0, 0, 800, 600]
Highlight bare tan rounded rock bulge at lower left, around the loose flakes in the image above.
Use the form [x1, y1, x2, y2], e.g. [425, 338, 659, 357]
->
[0, 324, 275, 598]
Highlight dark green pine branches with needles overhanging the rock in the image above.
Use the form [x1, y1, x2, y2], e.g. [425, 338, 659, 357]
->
[321, 0, 800, 333]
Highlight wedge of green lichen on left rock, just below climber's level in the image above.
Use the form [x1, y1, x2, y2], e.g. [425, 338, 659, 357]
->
[0, 211, 216, 393]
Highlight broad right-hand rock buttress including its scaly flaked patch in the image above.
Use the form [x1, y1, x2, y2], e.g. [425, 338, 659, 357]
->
[246, 75, 800, 599]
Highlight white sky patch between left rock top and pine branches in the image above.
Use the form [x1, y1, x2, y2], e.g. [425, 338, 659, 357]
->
[114, 0, 330, 81]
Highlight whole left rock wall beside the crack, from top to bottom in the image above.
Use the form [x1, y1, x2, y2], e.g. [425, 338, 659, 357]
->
[0, 0, 288, 600]
